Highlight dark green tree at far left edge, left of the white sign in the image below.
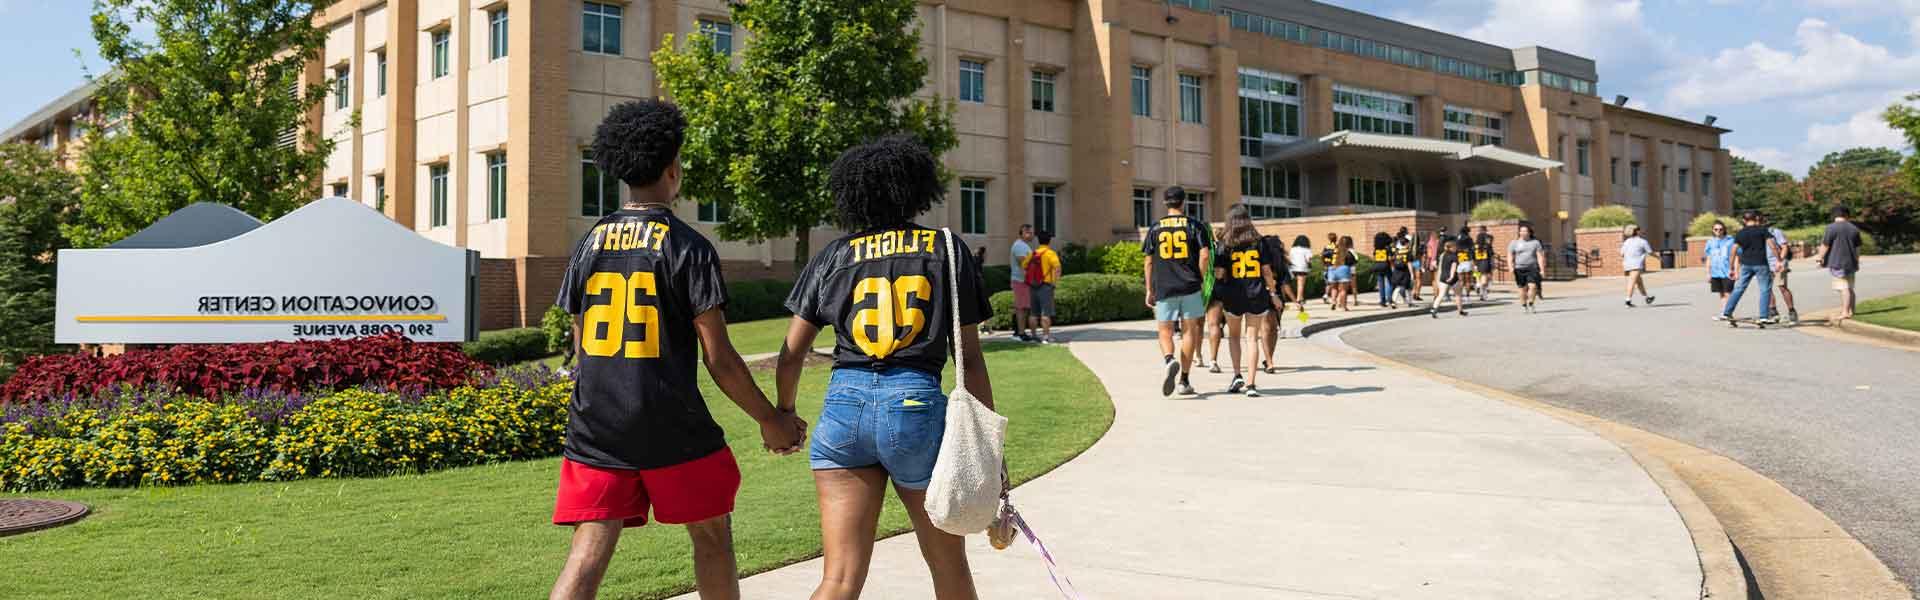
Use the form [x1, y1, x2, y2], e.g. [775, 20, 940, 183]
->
[0, 144, 81, 381]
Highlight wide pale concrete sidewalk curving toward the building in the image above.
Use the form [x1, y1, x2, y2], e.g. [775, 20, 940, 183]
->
[684, 304, 1701, 600]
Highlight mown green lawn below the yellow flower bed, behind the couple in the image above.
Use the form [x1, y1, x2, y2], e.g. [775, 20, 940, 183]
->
[0, 344, 1114, 600]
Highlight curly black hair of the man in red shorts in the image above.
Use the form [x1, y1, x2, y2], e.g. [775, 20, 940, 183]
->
[593, 100, 687, 187]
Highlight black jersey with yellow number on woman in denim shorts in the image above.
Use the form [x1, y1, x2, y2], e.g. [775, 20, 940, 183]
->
[787, 225, 993, 375]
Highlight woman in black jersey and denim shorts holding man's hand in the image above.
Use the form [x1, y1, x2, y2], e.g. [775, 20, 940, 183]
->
[776, 137, 998, 600]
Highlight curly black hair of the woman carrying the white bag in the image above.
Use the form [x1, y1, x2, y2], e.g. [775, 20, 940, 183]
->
[828, 135, 947, 233]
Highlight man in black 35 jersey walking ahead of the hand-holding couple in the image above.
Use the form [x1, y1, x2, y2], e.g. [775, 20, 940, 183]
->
[1140, 185, 1213, 396]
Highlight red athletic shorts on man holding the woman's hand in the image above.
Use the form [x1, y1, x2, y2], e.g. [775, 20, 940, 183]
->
[553, 448, 739, 527]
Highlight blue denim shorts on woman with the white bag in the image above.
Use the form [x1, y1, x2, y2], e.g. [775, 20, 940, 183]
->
[808, 367, 947, 490]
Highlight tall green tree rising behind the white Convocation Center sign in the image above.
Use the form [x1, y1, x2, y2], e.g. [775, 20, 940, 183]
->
[65, 0, 334, 246]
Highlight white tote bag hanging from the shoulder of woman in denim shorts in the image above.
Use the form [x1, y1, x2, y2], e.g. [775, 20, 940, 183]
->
[927, 229, 1006, 535]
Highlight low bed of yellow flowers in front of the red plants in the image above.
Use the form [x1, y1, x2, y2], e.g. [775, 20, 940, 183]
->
[0, 369, 572, 492]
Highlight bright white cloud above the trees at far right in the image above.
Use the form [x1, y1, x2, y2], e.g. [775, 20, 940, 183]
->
[1663, 19, 1920, 112]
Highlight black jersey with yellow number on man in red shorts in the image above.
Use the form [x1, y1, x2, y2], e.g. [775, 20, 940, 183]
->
[557, 208, 728, 469]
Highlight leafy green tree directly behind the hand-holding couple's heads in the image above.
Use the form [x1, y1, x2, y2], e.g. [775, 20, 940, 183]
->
[653, 0, 958, 263]
